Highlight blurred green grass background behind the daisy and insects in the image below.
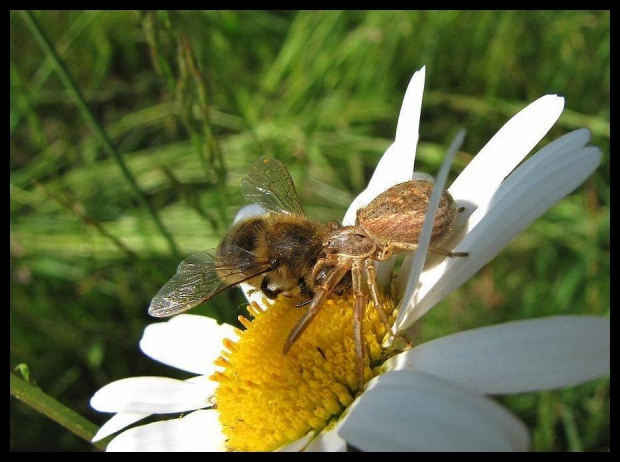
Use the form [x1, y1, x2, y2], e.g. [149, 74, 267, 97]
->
[10, 11, 610, 451]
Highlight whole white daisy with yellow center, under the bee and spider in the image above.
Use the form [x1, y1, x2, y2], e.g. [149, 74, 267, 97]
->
[91, 68, 610, 451]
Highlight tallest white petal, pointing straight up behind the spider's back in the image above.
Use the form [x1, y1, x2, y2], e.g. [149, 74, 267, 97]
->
[342, 67, 426, 226]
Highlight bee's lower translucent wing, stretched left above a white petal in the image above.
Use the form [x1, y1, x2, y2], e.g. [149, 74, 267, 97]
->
[149, 249, 271, 318]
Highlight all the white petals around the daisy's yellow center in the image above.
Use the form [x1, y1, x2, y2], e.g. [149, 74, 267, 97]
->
[91, 68, 610, 451]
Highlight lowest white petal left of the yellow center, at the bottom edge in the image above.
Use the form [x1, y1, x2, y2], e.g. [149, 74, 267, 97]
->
[106, 410, 226, 452]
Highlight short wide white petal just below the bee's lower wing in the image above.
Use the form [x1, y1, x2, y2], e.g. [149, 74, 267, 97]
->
[140, 314, 238, 375]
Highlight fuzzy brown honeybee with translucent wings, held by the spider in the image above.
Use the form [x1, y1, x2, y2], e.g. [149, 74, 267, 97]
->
[149, 157, 346, 317]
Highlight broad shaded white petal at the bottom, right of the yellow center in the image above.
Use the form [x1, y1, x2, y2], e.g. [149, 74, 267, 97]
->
[339, 371, 529, 451]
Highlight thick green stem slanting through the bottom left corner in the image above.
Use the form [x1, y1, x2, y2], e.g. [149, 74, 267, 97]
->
[9, 373, 107, 450]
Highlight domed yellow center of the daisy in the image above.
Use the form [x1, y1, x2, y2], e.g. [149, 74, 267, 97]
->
[211, 295, 394, 451]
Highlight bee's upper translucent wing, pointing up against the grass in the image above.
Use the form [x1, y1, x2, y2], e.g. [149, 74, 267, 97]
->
[241, 156, 305, 215]
